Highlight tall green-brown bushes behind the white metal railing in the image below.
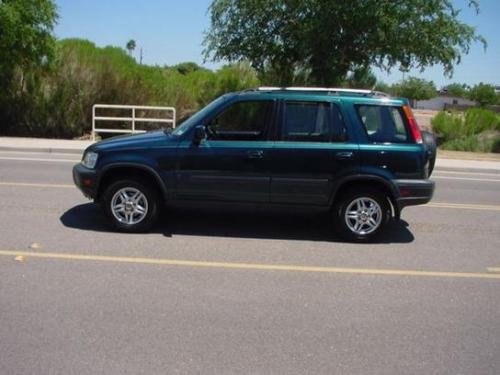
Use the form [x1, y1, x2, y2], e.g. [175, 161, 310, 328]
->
[0, 39, 259, 138]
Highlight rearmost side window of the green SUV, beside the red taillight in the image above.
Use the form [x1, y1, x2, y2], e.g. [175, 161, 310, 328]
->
[356, 105, 410, 143]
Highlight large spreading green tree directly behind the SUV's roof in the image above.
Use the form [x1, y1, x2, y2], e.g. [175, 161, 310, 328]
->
[204, 0, 485, 85]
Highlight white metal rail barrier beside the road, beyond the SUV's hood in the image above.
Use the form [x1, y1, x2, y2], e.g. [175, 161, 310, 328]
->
[92, 104, 176, 141]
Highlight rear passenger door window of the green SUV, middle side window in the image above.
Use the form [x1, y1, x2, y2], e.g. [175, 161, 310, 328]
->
[281, 102, 345, 142]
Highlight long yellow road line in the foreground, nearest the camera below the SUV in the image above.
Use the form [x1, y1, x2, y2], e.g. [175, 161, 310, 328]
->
[0, 250, 500, 280]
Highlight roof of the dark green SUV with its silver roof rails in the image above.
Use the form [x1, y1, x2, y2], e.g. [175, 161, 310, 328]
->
[234, 86, 407, 105]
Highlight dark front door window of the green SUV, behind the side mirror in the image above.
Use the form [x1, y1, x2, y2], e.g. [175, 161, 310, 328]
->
[207, 101, 273, 141]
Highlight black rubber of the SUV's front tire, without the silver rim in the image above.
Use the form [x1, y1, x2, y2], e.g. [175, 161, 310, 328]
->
[101, 180, 160, 233]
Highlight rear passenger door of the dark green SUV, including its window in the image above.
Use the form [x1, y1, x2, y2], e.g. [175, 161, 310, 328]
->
[270, 100, 359, 205]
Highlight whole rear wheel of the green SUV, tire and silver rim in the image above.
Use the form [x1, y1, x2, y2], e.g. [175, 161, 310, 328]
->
[334, 188, 391, 242]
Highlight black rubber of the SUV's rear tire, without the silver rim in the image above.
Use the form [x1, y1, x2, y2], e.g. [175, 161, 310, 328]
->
[333, 188, 391, 242]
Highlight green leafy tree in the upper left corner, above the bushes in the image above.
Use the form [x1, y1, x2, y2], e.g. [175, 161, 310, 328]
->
[0, 0, 57, 85]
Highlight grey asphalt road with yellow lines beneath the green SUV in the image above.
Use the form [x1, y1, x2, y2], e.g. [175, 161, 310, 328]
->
[0, 152, 500, 375]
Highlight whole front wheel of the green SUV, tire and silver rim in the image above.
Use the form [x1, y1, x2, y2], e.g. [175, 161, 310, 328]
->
[101, 180, 160, 233]
